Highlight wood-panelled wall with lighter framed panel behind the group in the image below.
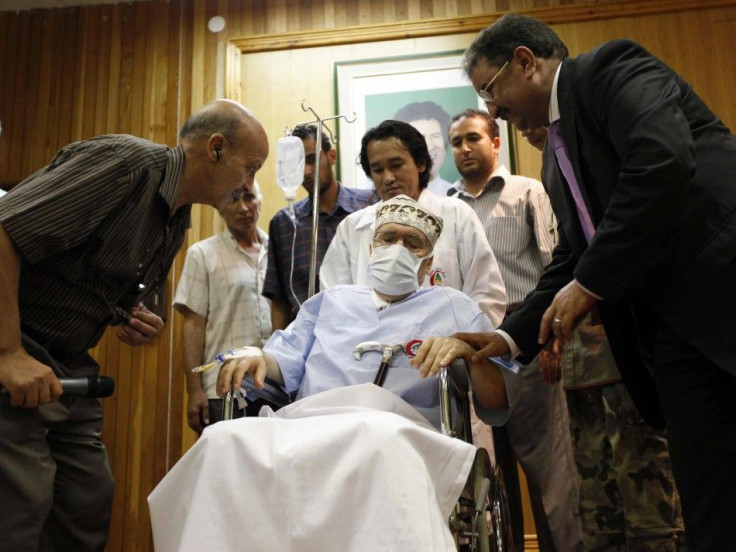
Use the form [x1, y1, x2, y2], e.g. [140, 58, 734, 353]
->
[0, 0, 736, 551]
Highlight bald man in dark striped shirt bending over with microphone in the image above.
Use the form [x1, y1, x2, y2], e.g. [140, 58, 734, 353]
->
[0, 100, 268, 551]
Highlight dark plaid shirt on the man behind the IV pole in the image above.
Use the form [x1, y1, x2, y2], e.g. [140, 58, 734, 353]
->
[263, 185, 375, 313]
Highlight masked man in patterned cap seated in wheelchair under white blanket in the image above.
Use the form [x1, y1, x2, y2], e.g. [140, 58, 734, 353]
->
[149, 196, 516, 552]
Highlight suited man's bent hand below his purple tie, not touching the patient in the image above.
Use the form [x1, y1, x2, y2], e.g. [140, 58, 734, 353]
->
[538, 280, 598, 346]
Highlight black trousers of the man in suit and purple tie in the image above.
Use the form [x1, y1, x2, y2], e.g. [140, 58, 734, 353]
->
[654, 326, 736, 552]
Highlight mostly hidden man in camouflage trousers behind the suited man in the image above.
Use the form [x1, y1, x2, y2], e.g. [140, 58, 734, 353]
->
[540, 310, 688, 552]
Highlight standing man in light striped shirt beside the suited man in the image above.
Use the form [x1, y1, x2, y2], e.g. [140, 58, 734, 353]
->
[448, 109, 583, 552]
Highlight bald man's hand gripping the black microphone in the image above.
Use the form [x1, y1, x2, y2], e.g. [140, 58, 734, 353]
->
[0, 347, 62, 408]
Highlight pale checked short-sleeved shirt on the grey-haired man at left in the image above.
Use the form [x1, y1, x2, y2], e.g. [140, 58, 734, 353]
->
[174, 229, 271, 399]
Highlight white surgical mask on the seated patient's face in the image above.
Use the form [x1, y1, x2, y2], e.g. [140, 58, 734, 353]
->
[368, 243, 424, 295]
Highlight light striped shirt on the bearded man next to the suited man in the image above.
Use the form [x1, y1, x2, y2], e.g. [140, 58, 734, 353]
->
[448, 166, 557, 313]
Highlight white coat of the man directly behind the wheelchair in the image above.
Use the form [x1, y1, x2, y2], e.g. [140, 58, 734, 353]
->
[320, 189, 506, 326]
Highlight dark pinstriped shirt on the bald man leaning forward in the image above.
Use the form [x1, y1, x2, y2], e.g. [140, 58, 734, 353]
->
[0, 135, 191, 362]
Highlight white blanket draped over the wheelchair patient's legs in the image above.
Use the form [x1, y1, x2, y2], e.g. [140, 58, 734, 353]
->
[148, 384, 475, 552]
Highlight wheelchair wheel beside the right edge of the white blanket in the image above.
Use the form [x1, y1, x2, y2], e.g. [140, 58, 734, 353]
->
[450, 449, 513, 552]
